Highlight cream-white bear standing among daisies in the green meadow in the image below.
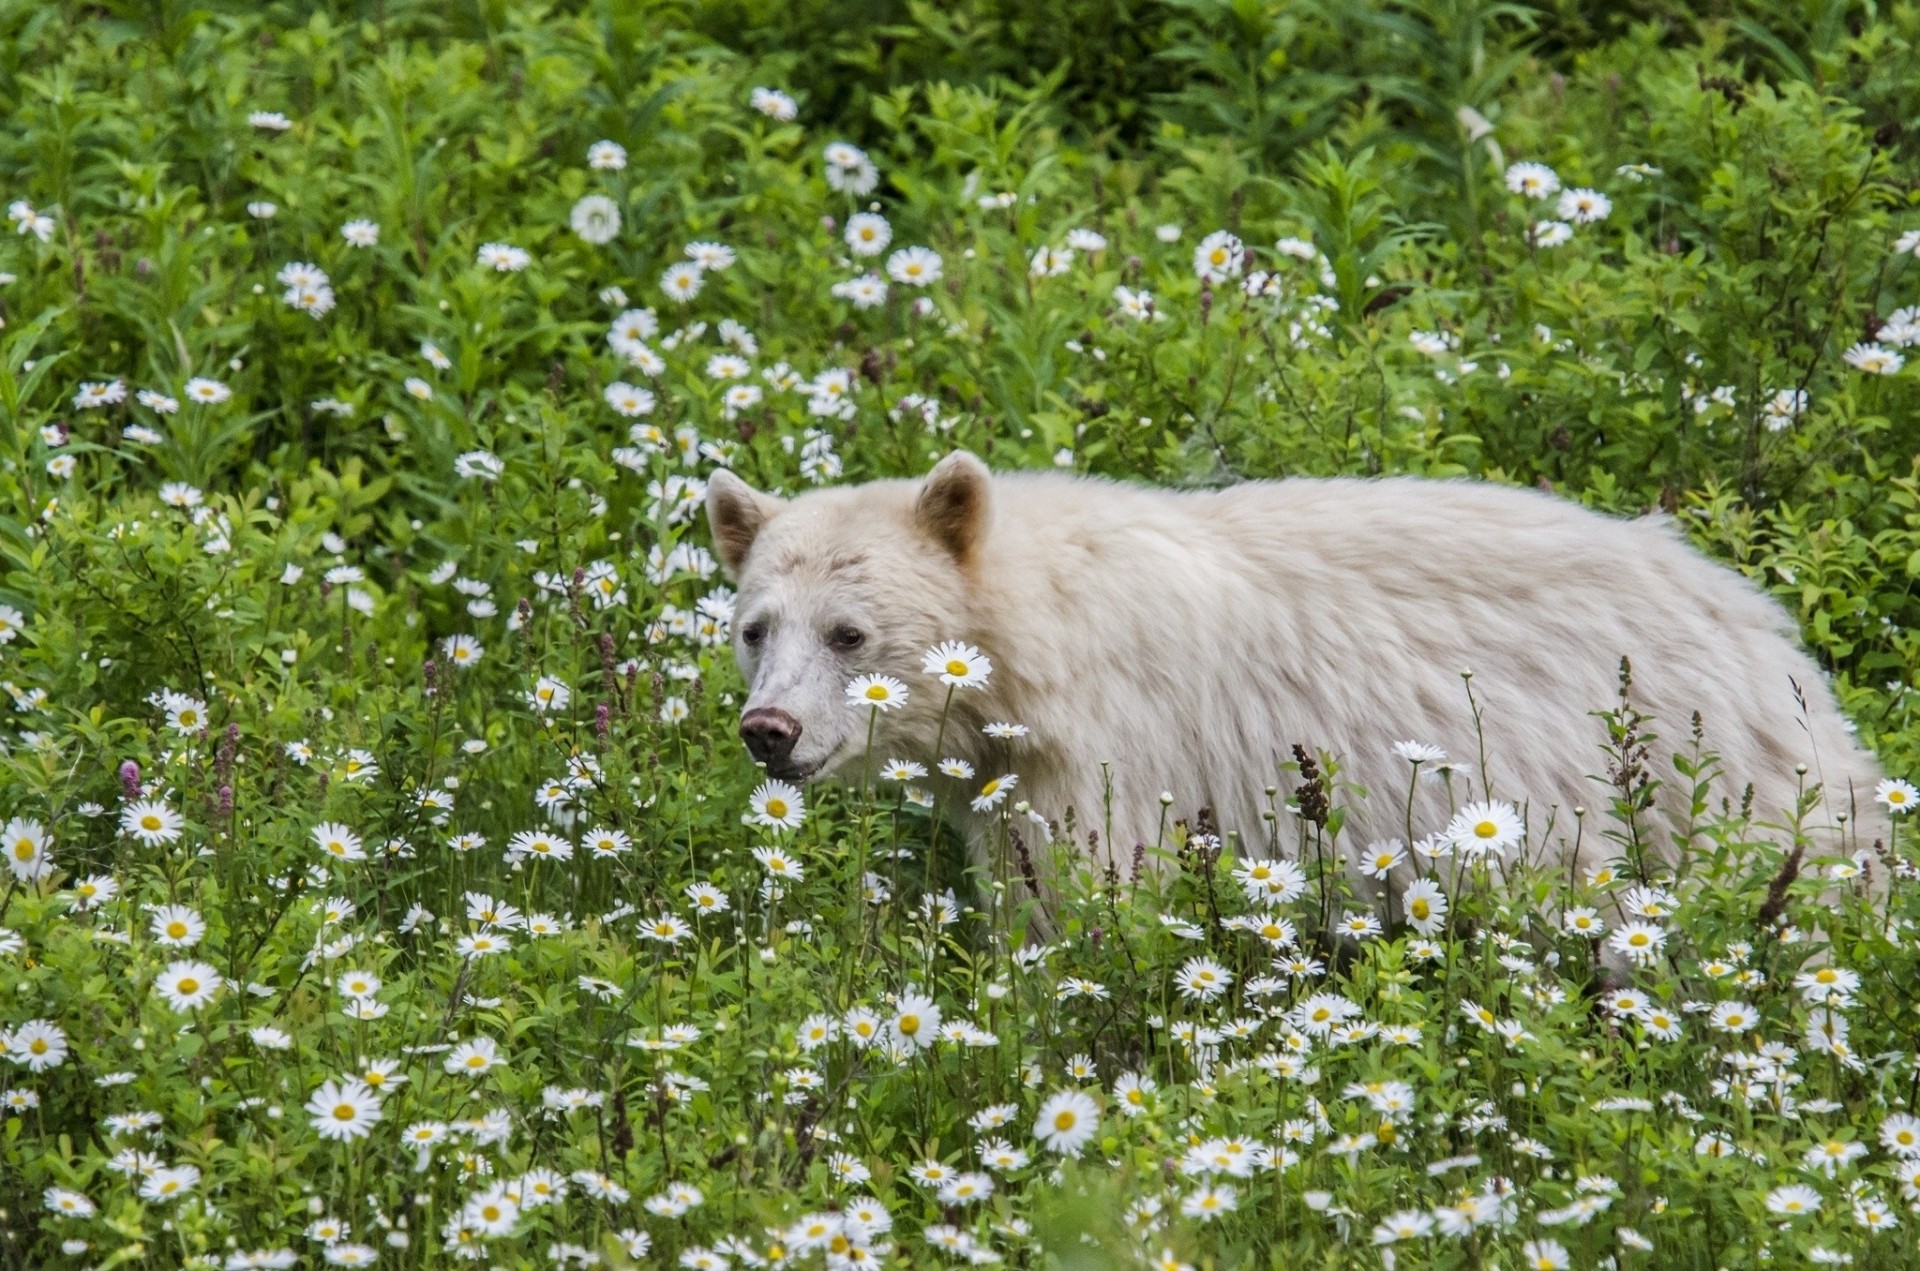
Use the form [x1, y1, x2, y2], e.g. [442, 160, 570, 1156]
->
[707, 453, 1880, 887]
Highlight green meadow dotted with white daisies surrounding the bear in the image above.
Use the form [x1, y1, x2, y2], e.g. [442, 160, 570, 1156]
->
[0, 0, 1920, 1271]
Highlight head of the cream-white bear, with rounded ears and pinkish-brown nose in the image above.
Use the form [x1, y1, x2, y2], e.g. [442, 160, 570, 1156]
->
[707, 451, 991, 781]
